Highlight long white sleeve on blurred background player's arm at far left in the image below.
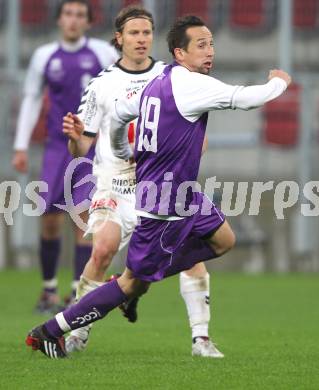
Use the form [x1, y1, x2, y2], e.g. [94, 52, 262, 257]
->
[13, 49, 44, 150]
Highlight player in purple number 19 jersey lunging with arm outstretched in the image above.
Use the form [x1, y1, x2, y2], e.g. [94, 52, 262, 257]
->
[26, 16, 291, 358]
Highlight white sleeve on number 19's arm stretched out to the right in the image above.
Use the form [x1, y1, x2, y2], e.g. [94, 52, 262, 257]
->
[172, 67, 287, 122]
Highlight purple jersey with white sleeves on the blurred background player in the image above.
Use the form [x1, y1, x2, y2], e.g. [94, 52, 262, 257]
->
[14, 37, 118, 150]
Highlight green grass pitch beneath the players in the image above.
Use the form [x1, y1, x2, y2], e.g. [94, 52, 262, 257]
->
[0, 270, 319, 390]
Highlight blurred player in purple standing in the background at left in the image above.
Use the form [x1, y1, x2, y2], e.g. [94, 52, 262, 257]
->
[12, 0, 118, 313]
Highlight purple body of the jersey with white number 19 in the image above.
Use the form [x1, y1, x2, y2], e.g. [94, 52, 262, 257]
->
[135, 64, 208, 215]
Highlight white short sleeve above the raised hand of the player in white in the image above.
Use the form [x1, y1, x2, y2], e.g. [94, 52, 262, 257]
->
[77, 77, 106, 137]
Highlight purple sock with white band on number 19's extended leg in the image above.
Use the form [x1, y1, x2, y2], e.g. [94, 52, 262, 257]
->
[45, 280, 127, 337]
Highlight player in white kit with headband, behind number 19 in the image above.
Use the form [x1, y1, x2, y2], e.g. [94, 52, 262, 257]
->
[64, 6, 223, 358]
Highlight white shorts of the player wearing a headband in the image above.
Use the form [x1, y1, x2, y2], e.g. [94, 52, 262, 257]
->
[84, 167, 137, 250]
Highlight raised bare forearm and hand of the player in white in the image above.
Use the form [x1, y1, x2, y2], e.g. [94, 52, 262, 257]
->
[63, 112, 94, 157]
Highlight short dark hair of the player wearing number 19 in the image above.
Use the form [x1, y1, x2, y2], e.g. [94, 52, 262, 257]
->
[167, 15, 206, 56]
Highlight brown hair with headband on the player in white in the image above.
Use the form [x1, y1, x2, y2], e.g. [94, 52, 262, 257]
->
[111, 4, 154, 51]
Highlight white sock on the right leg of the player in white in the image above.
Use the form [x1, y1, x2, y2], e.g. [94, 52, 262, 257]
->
[179, 272, 210, 339]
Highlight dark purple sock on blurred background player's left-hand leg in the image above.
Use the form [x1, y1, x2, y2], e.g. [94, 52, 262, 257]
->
[40, 238, 61, 286]
